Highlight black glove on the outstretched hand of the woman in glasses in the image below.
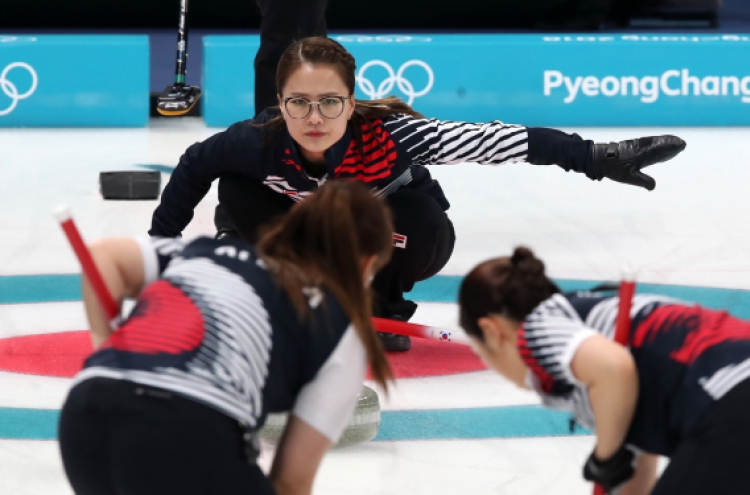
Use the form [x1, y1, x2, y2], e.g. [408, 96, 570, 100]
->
[586, 136, 685, 191]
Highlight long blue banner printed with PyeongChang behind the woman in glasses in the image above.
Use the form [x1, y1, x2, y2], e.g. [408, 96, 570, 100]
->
[203, 34, 750, 127]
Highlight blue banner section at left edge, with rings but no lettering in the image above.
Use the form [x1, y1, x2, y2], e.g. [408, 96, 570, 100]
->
[0, 35, 149, 127]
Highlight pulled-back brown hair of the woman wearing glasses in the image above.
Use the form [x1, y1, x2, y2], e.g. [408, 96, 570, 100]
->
[265, 37, 424, 158]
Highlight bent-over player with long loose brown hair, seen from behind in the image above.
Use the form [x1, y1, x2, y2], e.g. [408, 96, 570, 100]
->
[59, 181, 393, 495]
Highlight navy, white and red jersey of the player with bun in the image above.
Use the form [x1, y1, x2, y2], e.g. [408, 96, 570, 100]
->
[518, 292, 750, 456]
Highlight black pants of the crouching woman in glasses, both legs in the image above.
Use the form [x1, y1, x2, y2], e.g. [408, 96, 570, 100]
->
[215, 174, 456, 320]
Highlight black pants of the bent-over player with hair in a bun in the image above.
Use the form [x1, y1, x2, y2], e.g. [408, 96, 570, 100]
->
[651, 380, 750, 495]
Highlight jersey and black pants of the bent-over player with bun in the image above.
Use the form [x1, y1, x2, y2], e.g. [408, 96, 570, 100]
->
[518, 292, 750, 494]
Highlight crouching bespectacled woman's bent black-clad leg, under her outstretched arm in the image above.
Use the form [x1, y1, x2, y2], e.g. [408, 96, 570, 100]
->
[372, 188, 456, 351]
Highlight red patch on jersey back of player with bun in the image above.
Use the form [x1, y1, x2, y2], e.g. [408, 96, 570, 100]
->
[632, 305, 750, 364]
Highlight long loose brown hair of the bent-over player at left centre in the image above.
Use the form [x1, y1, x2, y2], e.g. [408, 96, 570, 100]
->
[257, 180, 393, 391]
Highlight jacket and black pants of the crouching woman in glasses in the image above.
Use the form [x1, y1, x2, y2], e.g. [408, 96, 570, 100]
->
[149, 112, 593, 319]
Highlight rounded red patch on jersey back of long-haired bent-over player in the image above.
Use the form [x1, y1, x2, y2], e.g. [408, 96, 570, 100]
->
[101, 280, 205, 354]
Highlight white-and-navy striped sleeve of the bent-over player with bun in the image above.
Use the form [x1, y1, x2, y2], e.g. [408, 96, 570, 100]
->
[518, 294, 597, 395]
